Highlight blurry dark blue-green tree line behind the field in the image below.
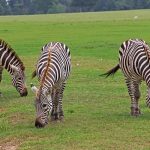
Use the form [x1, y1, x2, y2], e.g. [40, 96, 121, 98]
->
[0, 0, 150, 15]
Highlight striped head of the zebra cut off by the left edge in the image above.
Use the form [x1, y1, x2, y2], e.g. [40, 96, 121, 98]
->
[11, 65, 28, 96]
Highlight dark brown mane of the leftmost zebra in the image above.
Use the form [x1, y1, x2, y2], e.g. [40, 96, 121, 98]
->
[0, 39, 25, 71]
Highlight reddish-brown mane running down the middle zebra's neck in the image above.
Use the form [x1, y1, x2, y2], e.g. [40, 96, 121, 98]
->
[39, 48, 51, 91]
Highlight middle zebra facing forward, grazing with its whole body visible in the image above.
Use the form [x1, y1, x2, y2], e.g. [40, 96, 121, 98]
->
[31, 42, 71, 128]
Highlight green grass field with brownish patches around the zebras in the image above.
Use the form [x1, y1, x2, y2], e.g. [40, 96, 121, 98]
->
[0, 10, 150, 150]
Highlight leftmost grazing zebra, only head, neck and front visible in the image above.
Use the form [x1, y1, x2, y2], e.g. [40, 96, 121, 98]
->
[0, 39, 28, 96]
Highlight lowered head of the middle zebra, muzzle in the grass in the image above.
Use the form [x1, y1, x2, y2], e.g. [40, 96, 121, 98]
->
[31, 84, 52, 128]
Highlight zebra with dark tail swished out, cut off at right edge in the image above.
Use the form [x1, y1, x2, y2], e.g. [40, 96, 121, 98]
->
[104, 39, 150, 116]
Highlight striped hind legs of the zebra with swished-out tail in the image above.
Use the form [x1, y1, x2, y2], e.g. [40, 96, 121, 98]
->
[126, 79, 141, 116]
